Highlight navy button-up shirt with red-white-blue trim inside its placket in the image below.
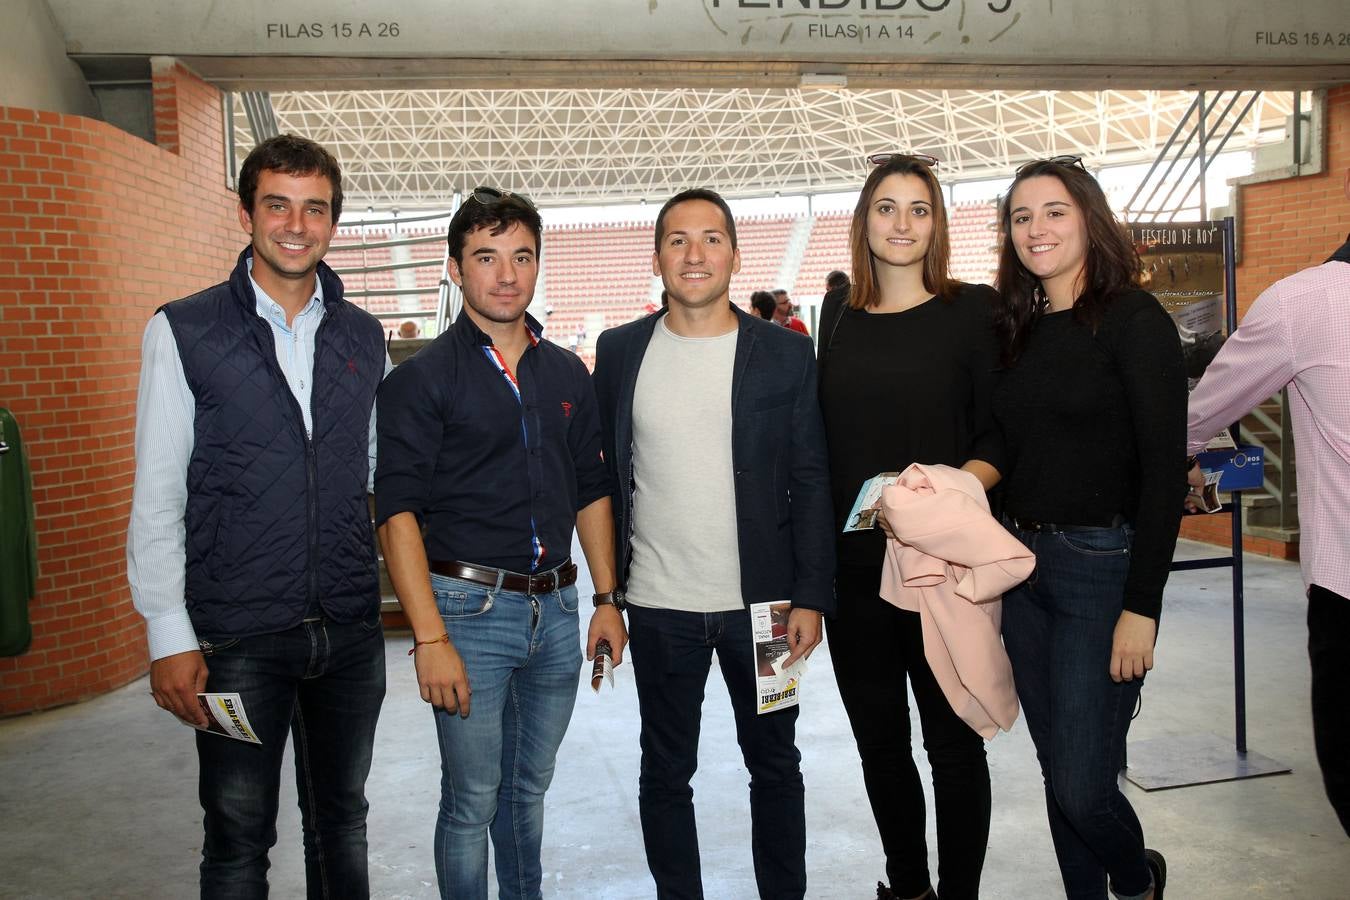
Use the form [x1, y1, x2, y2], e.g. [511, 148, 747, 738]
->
[375, 314, 610, 572]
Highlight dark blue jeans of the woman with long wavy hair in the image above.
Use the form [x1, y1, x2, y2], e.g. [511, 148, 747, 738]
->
[1003, 526, 1152, 900]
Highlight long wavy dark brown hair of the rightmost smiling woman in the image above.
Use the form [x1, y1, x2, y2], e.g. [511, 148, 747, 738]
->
[994, 159, 1139, 366]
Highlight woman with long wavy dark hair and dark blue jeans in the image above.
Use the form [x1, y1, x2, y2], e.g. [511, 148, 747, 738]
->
[994, 157, 1187, 900]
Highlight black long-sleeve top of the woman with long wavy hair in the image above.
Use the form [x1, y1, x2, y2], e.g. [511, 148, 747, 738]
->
[991, 290, 1187, 618]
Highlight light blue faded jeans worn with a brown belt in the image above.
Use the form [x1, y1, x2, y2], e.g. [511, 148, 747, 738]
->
[431, 575, 582, 900]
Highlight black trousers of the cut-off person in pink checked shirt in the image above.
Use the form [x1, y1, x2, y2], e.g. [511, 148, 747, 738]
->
[1308, 584, 1350, 835]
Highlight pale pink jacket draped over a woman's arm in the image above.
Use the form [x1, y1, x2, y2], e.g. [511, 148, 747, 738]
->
[880, 463, 1035, 739]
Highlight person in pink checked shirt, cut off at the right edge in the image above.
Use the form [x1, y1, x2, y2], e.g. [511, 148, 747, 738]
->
[1187, 171, 1350, 834]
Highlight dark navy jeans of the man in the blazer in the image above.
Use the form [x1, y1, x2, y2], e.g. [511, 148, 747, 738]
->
[628, 606, 806, 900]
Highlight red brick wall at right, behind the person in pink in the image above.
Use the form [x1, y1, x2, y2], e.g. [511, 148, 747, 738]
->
[1181, 85, 1350, 559]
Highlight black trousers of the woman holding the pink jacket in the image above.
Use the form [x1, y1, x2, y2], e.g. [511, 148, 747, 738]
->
[828, 565, 990, 900]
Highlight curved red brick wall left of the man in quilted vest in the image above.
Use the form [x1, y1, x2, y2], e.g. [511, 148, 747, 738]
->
[0, 61, 243, 715]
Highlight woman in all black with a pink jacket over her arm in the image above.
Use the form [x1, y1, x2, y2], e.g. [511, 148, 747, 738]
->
[819, 155, 998, 900]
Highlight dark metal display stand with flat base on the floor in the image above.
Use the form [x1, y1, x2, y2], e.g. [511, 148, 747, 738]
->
[1125, 216, 1292, 791]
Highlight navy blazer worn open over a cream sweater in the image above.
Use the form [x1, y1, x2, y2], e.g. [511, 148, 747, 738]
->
[594, 309, 834, 615]
